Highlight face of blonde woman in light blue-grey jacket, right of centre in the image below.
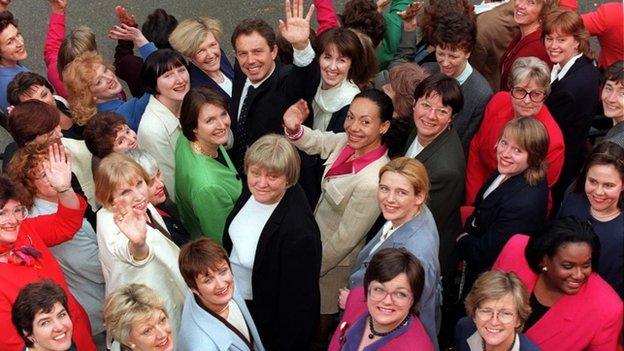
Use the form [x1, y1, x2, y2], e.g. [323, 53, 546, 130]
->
[377, 171, 425, 228]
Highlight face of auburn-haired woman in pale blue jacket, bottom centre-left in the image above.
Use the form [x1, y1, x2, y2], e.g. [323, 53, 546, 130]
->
[192, 261, 234, 312]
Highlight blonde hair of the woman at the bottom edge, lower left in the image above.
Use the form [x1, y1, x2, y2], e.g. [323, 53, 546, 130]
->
[103, 284, 169, 351]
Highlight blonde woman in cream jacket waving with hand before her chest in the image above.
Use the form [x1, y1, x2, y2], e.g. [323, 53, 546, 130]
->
[95, 153, 186, 331]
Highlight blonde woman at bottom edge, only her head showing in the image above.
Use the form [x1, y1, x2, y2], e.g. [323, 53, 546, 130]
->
[104, 284, 175, 351]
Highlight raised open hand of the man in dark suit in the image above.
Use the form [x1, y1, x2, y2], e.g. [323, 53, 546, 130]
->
[279, 0, 314, 50]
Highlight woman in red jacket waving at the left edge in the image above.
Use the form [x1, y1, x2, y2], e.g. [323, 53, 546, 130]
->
[0, 144, 95, 351]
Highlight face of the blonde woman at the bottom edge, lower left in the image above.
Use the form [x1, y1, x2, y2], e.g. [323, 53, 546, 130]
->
[126, 310, 173, 351]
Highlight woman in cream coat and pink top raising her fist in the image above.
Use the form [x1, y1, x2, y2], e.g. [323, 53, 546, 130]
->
[284, 89, 393, 342]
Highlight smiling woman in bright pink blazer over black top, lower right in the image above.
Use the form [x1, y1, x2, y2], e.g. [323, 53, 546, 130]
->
[493, 217, 623, 351]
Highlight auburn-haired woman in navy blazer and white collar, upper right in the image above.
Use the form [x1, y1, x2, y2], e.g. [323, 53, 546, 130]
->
[543, 9, 600, 213]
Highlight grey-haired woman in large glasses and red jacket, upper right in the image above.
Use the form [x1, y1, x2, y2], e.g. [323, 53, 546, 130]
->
[466, 57, 564, 209]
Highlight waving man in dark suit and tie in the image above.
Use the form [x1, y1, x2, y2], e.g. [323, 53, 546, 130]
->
[230, 0, 320, 171]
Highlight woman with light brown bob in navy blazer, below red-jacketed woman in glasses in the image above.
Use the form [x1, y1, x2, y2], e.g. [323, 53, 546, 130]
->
[457, 117, 548, 292]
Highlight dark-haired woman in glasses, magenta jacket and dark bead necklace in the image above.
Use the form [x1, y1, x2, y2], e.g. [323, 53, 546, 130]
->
[328, 248, 434, 351]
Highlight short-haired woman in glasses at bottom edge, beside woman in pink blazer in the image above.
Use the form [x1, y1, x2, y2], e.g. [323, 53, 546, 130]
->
[455, 271, 539, 351]
